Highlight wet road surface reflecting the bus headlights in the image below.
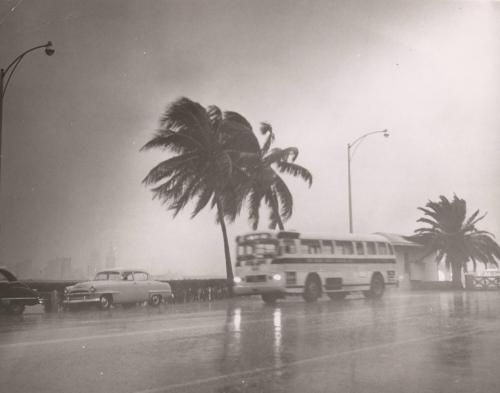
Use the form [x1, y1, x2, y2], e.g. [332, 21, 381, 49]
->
[0, 291, 500, 393]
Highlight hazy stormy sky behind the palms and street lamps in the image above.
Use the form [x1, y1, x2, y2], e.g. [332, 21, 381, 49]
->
[0, 0, 500, 275]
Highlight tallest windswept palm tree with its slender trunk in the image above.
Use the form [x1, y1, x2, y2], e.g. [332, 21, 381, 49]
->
[141, 98, 259, 288]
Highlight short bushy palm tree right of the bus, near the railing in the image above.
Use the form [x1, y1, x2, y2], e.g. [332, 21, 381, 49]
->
[407, 195, 500, 289]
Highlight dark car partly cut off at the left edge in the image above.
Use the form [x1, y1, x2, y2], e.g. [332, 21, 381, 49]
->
[0, 267, 41, 314]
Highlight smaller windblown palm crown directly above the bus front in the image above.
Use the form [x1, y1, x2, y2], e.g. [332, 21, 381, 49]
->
[227, 123, 312, 230]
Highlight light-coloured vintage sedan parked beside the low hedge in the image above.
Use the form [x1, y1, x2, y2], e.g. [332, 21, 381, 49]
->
[63, 268, 172, 309]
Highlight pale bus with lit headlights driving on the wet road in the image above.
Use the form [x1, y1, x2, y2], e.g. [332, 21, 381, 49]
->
[233, 231, 397, 303]
